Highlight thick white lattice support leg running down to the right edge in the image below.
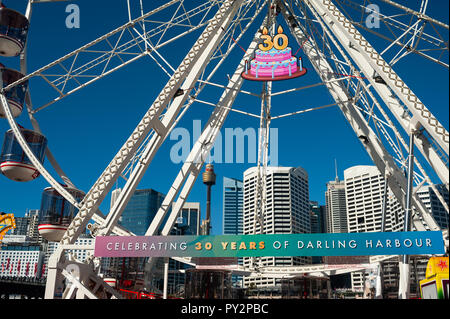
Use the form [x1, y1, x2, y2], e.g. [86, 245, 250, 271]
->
[306, 0, 449, 179]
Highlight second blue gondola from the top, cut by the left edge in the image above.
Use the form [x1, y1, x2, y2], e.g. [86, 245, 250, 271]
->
[0, 63, 28, 117]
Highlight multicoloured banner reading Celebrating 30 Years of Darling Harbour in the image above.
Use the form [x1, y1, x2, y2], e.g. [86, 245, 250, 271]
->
[94, 231, 445, 257]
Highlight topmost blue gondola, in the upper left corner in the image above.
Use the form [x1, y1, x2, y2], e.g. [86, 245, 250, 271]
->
[0, 8, 30, 57]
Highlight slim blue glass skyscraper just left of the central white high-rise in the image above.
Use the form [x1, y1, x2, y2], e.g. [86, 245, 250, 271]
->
[223, 177, 243, 235]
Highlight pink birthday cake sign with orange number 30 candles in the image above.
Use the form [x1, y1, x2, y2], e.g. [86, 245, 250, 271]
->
[242, 26, 306, 81]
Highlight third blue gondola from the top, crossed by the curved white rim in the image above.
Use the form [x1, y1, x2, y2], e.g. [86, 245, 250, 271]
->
[0, 128, 47, 182]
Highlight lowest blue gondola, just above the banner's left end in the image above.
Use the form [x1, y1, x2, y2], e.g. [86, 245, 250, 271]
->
[38, 186, 85, 242]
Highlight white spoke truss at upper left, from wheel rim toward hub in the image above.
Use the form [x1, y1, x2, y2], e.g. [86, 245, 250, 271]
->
[5, 0, 229, 114]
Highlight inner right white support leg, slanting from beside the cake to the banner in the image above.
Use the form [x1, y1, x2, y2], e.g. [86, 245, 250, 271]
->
[280, 1, 439, 235]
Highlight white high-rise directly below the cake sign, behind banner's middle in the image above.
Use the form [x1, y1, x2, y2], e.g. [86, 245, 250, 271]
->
[243, 167, 311, 288]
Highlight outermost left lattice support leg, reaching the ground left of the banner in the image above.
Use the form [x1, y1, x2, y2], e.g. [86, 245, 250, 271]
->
[46, 0, 246, 298]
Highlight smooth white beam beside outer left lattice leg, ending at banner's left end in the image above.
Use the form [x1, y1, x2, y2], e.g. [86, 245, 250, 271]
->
[99, 0, 244, 236]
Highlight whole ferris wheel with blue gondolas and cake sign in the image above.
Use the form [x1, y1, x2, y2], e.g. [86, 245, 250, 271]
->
[0, 0, 449, 298]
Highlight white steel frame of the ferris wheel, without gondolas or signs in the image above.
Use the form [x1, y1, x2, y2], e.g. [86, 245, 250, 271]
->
[0, 0, 449, 298]
